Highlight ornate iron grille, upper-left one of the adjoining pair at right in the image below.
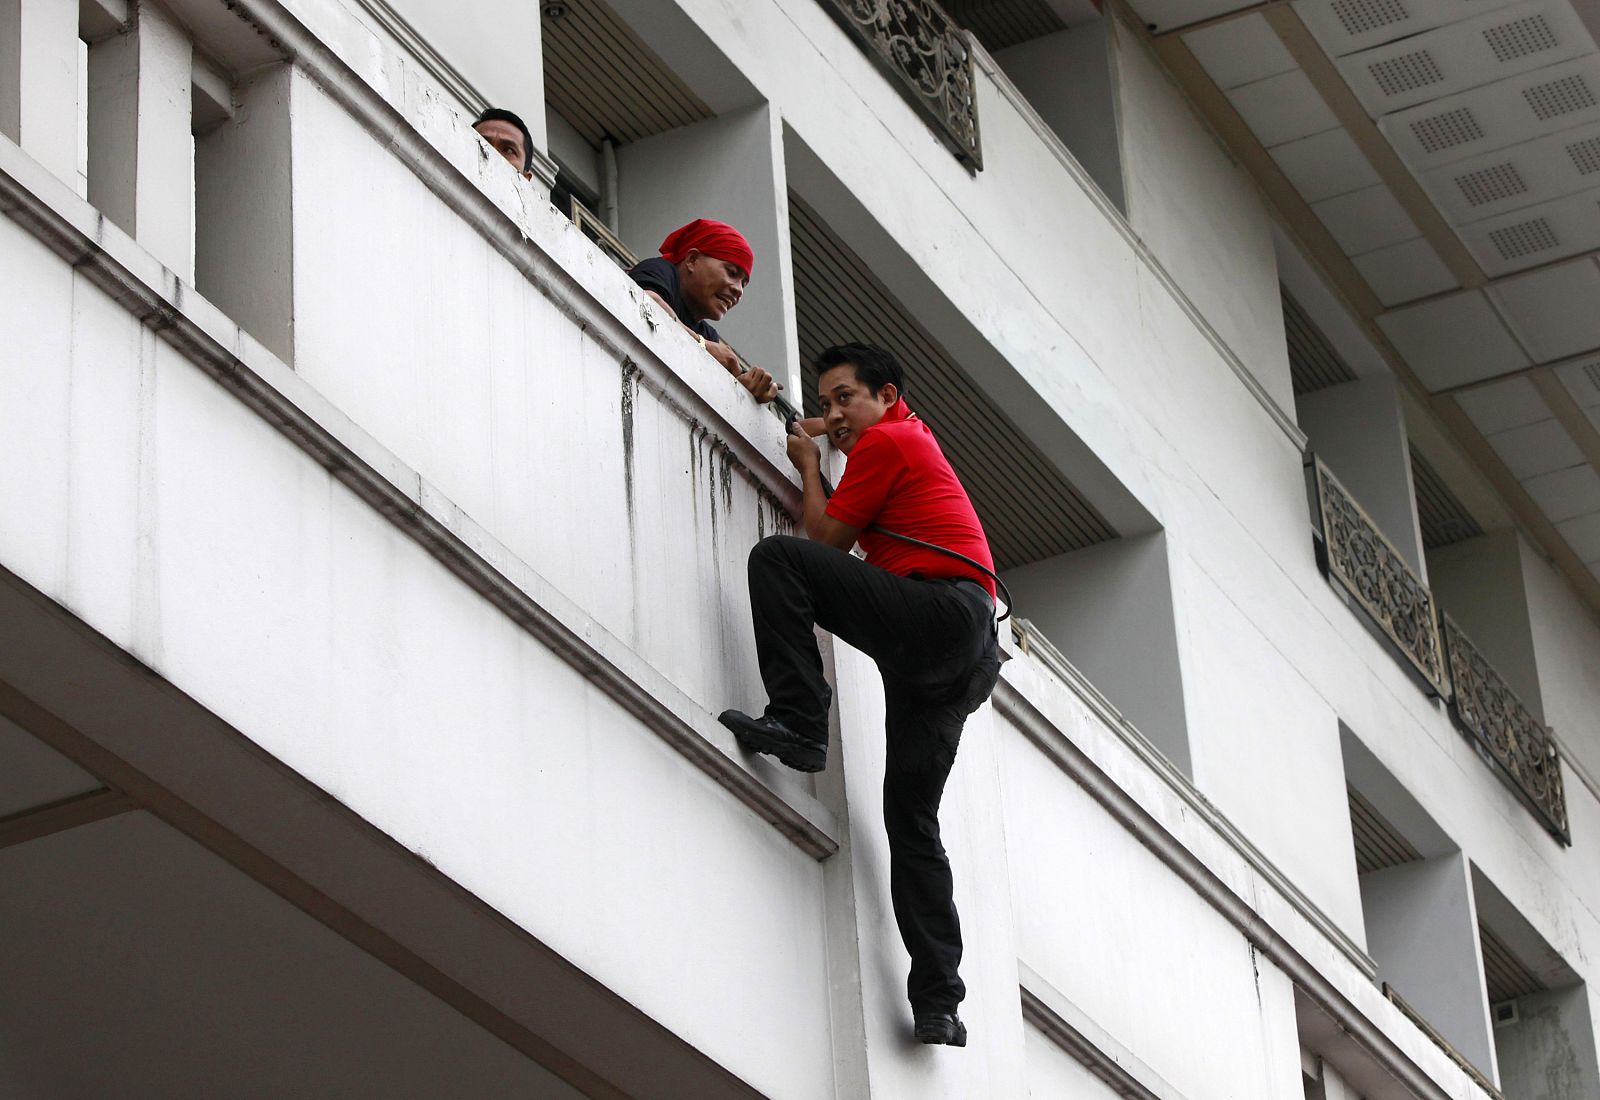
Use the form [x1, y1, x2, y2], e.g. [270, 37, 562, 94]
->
[1315, 459, 1450, 695]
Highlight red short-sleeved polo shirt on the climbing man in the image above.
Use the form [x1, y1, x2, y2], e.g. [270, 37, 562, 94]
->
[827, 398, 995, 598]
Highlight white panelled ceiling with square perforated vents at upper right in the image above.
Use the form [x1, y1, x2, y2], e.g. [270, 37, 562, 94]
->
[1131, 0, 1600, 591]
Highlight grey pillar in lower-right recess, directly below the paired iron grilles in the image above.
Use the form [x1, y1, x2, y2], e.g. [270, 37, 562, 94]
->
[1362, 852, 1498, 1081]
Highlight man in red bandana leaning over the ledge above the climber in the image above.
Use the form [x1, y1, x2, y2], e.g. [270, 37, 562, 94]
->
[629, 217, 782, 401]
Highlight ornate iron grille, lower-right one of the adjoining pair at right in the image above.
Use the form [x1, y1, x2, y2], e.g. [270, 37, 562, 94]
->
[1445, 616, 1573, 844]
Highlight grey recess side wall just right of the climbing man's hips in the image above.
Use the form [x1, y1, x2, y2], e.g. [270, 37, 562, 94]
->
[1005, 531, 1194, 775]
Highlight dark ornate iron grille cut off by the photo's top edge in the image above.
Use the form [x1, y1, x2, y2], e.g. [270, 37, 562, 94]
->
[821, 0, 984, 168]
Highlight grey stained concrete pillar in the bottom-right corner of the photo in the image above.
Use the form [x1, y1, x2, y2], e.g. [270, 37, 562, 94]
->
[1494, 985, 1600, 1100]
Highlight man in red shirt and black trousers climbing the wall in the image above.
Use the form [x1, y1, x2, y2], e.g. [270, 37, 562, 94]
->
[720, 344, 1000, 1046]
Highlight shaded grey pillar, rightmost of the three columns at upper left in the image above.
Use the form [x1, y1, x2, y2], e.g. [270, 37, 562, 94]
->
[195, 62, 294, 363]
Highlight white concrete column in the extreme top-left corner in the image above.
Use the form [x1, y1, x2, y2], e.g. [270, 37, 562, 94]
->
[0, 0, 78, 184]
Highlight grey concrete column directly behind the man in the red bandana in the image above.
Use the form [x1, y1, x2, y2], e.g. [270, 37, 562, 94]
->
[616, 104, 800, 398]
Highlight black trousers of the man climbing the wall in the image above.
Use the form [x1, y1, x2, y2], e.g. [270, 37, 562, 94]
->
[750, 536, 1000, 1012]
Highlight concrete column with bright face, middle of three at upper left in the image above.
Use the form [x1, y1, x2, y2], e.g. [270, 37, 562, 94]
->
[90, 0, 195, 281]
